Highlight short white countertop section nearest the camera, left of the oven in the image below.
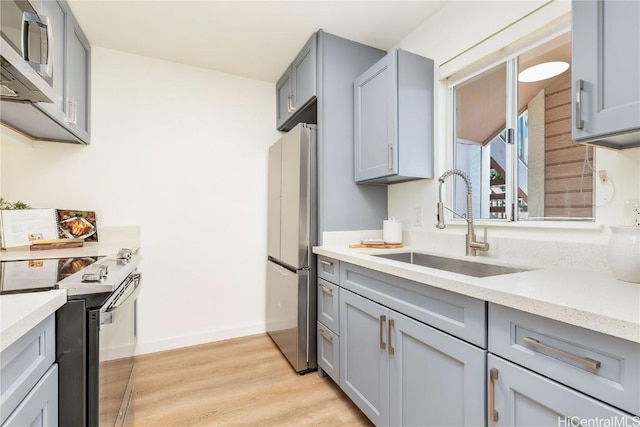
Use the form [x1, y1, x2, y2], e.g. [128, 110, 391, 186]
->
[0, 289, 67, 351]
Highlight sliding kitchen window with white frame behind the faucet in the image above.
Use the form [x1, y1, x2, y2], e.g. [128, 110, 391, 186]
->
[450, 32, 594, 221]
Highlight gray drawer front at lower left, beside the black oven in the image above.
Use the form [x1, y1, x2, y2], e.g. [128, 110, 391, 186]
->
[0, 314, 55, 423]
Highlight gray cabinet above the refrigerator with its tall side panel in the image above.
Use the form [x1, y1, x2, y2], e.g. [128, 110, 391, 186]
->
[276, 30, 388, 245]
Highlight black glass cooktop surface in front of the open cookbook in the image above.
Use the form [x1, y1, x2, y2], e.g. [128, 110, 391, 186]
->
[0, 257, 101, 295]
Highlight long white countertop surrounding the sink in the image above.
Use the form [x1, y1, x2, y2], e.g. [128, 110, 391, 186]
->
[313, 246, 640, 343]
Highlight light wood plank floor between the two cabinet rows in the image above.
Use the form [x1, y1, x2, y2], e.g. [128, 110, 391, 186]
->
[126, 334, 372, 427]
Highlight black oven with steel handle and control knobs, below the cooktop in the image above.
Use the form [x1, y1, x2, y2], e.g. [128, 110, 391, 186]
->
[56, 254, 141, 427]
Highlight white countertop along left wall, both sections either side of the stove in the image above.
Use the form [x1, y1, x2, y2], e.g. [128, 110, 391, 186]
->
[0, 226, 140, 351]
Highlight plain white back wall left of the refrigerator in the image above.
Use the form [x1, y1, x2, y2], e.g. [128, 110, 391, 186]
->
[1, 47, 280, 353]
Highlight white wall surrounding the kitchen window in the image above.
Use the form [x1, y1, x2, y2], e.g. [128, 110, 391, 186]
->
[389, 1, 640, 244]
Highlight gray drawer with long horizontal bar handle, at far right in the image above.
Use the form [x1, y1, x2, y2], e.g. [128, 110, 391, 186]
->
[489, 304, 640, 415]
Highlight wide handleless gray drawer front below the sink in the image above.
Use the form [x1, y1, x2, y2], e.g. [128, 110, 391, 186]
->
[340, 262, 487, 348]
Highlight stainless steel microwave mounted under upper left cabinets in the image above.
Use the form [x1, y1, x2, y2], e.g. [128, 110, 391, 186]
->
[0, 0, 54, 102]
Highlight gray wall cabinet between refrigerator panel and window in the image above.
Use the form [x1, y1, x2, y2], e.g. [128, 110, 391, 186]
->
[354, 49, 434, 184]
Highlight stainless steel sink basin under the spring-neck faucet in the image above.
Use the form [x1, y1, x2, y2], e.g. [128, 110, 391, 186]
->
[374, 252, 527, 277]
